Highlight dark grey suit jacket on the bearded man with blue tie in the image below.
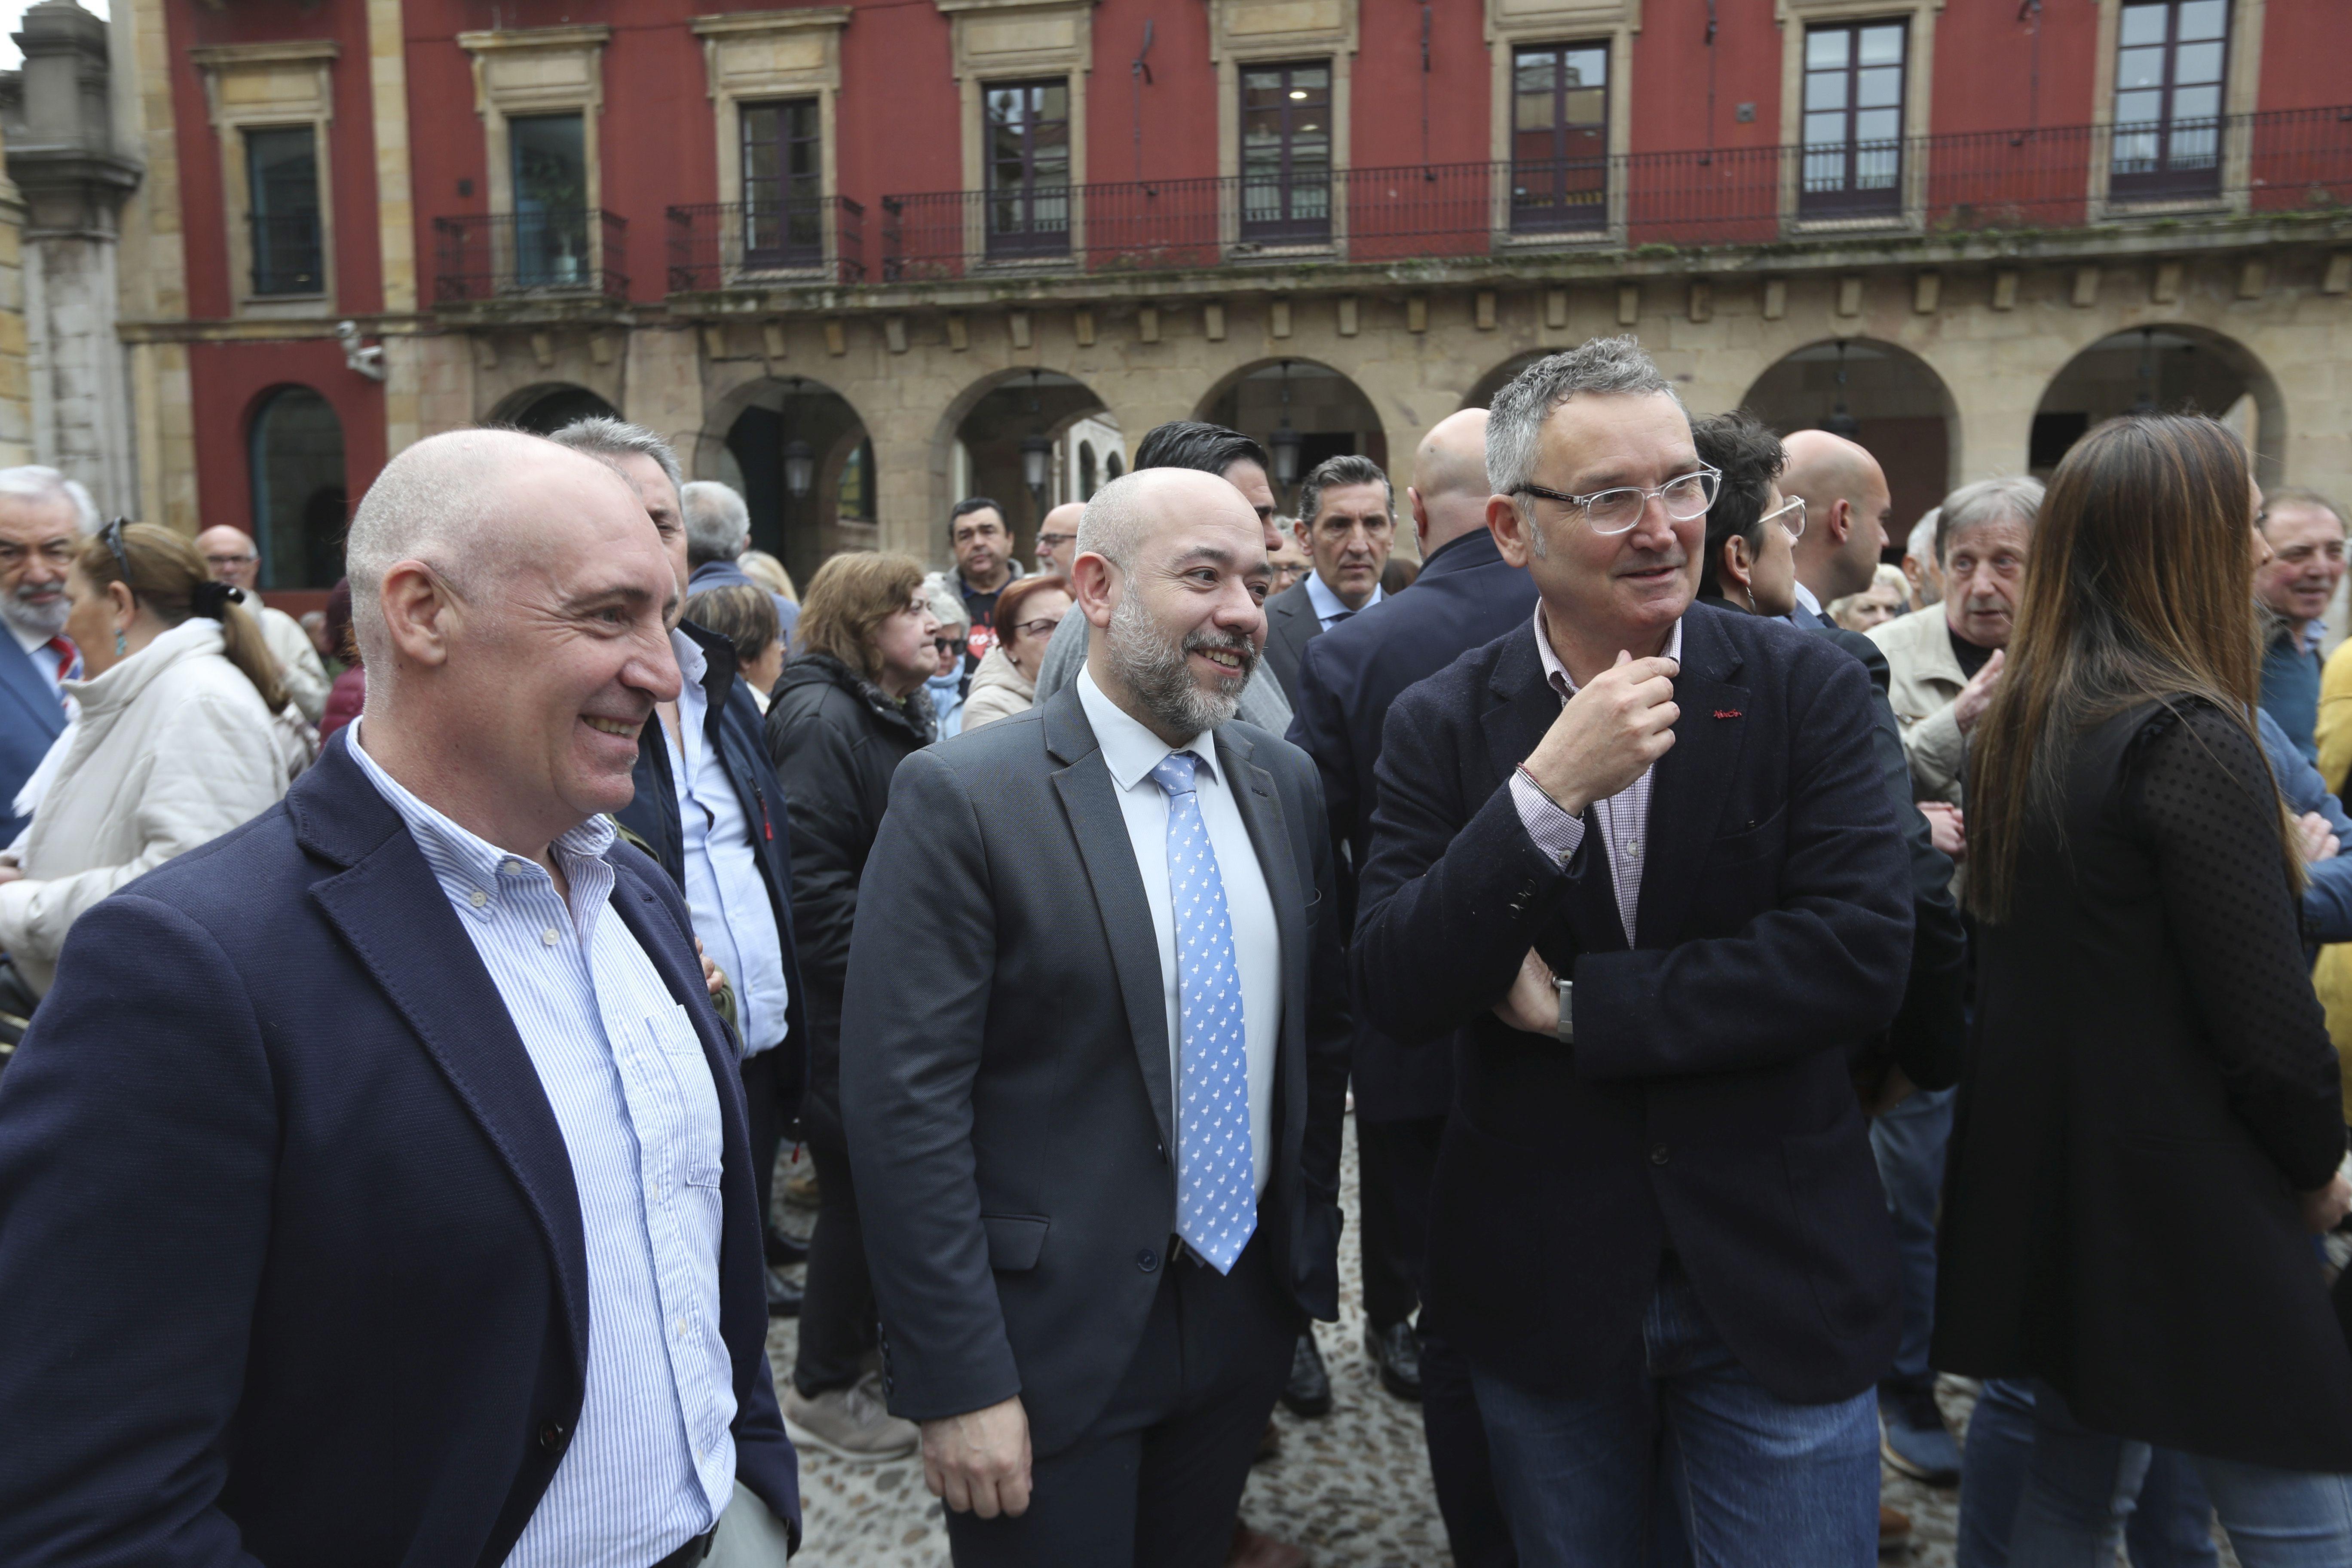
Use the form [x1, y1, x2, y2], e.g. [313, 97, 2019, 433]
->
[842, 691, 1350, 1458]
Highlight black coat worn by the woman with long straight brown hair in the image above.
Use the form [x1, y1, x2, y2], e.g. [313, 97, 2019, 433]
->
[1933, 703, 2352, 1472]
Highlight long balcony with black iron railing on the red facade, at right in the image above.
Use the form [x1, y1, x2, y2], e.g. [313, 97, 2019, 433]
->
[880, 108, 2352, 282]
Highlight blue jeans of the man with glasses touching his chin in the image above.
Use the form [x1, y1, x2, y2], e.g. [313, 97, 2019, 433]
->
[1472, 1265, 1879, 1568]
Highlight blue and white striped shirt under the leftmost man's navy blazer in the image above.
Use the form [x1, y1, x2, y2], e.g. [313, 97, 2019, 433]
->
[350, 720, 736, 1568]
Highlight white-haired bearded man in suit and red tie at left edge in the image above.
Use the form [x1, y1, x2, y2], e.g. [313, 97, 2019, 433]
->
[0, 468, 99, 844]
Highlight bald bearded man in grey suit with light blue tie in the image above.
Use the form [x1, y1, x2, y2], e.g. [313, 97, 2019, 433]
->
[842, 468, 1348, 1568]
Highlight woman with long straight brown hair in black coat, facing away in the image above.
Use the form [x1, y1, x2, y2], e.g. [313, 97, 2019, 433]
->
[1933, 414, 2352, 1568]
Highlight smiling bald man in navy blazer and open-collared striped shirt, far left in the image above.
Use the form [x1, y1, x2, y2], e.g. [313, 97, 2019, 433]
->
[0, 430, 799, 1568]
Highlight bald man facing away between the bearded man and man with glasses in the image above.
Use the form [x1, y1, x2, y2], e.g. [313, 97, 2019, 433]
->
[1291, 409, 1536, 1568]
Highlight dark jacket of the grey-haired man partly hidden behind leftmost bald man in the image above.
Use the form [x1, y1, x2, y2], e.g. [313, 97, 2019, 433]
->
[614, 621, 809, 1114]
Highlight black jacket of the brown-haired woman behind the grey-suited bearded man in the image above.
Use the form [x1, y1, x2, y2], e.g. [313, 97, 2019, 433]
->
[767, 653, 936, 1149]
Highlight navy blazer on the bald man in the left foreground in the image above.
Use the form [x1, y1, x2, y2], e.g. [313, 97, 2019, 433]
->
[0, 731, 799, 1568]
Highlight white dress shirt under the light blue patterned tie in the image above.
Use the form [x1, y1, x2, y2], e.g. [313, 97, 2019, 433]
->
[1077, 670, 1282, 1229]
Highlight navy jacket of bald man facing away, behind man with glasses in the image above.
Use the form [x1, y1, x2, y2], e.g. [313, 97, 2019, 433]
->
[1289, 529, 1536, 1121]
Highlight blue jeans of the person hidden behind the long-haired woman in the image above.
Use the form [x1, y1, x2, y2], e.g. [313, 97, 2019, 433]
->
[1954, 1378, 2220, 1568]
